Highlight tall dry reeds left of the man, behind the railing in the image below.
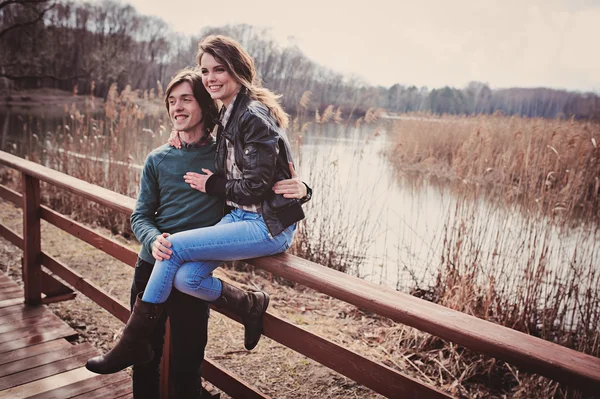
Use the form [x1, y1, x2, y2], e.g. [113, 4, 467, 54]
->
[4, 83, 170, 236]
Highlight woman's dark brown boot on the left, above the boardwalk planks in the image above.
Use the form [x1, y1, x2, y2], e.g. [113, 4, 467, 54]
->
[85, 292, 164, 374]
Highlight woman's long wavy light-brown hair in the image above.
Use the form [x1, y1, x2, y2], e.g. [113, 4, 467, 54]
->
[196, 35, 289, 128]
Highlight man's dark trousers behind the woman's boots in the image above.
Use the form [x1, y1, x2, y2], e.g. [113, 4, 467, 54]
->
[131, 258, 210, 399]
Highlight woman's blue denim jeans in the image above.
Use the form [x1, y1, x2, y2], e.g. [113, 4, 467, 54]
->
[142, 208, 296, 303]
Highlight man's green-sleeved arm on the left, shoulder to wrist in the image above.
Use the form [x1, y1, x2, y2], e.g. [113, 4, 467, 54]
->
[130, 157, 161, 260]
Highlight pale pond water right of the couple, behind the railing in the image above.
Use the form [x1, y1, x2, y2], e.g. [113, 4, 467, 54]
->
[301, 125, 598, 290]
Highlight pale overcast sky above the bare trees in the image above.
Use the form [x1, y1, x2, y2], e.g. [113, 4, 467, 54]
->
[101, 0, 600, 92]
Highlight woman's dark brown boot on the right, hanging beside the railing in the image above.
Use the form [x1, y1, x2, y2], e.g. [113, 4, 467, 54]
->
[214, 280, 269, 350]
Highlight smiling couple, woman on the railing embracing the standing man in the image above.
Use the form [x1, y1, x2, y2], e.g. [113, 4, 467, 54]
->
[86, 36, 311, 398]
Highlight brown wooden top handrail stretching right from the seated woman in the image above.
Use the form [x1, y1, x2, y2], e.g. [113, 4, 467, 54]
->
[249, 253, 600, 392]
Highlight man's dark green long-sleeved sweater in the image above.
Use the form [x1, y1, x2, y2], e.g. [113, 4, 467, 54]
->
[131, 139, 223, 264]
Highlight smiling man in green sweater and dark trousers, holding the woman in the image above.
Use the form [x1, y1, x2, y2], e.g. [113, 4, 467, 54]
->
[131, 69, 307, 399]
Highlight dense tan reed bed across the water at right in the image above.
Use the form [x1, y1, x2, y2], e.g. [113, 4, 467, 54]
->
[388, 114, 600, 224]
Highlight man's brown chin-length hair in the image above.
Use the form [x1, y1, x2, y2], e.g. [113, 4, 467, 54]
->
[165, 68, 219, 131]
